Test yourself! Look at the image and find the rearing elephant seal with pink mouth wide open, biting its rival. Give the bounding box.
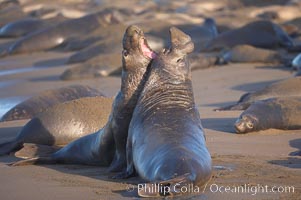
[13,26,155,171]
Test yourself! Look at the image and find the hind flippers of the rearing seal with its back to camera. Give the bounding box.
[138,173,192,197]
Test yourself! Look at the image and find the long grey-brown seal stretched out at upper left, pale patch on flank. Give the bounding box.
[2,10,119,56]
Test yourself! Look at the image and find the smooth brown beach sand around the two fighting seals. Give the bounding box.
[0,52,301,200]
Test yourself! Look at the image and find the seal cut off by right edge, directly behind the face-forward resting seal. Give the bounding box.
[215,77,301,111]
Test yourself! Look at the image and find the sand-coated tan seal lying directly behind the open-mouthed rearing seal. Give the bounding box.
[0,97,113,155]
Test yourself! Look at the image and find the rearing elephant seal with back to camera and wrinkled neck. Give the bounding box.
[116,27,212,195]
